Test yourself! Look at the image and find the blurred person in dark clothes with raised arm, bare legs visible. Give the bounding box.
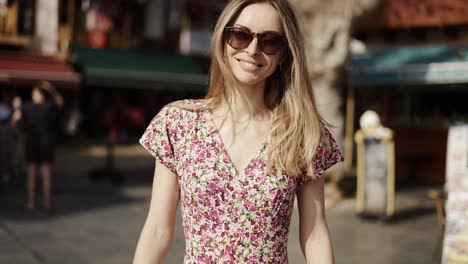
[14,81,64,212]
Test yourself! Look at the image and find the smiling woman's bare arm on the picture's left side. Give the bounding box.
[133,161,179,264]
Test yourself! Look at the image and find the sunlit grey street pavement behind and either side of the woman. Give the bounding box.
[0,145,439,264]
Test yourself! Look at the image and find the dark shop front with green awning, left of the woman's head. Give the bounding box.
[72,46,208,142]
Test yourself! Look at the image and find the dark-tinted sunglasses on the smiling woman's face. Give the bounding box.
[225,27,286,55]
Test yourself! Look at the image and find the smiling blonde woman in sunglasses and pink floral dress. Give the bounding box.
[134,0,342,263]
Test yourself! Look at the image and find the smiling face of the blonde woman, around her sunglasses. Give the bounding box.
[225,3,284,87]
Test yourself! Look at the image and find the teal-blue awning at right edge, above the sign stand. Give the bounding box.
[349,46,468,86]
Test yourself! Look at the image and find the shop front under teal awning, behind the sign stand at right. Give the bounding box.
[347,45,468,186]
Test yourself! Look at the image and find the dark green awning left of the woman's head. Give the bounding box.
[72,46,208,90]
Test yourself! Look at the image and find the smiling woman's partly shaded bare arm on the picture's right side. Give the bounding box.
[297,178,334,264]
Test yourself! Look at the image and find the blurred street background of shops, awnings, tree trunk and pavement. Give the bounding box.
[0,0,468,263]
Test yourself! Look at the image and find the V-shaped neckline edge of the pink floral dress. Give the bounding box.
[207,108,270,176]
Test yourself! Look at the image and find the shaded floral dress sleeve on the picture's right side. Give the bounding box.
[304,122,344,183]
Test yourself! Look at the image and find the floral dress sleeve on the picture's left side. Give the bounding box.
[139,107,176,173]
